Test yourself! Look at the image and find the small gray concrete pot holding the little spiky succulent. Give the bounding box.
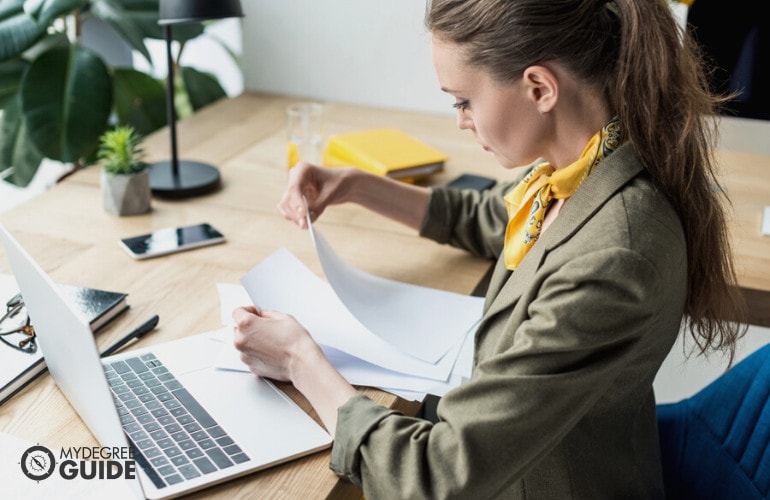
[102,170,151,215]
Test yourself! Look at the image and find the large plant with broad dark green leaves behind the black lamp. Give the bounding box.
[0,0,234,187]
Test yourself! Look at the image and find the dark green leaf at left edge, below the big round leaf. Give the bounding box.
[0,96,43,187]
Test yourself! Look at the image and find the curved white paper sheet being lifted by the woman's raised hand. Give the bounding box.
[308,218,482,363]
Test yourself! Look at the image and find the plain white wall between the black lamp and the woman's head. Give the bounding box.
[241,0,452,113]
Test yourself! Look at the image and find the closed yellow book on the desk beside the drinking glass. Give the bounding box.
[323,128,447,181]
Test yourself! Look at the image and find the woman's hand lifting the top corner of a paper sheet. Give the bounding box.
[278,162,356,229]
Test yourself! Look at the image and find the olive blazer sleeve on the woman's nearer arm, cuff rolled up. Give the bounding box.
[331,247,676,499]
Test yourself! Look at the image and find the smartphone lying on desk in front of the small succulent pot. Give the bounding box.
[120,223,225,260]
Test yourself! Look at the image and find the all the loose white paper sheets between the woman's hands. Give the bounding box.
[218,221,483,400]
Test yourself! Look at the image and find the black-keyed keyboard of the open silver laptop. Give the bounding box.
[104,353,249,488]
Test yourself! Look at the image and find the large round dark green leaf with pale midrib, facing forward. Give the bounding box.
[21,45,112,162]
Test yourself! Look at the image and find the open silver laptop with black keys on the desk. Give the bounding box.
[0,225,332,499]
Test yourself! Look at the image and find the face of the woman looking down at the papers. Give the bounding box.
[433,36,547,168]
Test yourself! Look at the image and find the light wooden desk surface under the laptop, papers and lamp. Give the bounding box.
[0,94,770,498]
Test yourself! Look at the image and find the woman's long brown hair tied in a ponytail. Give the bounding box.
[425,0,747,360]
